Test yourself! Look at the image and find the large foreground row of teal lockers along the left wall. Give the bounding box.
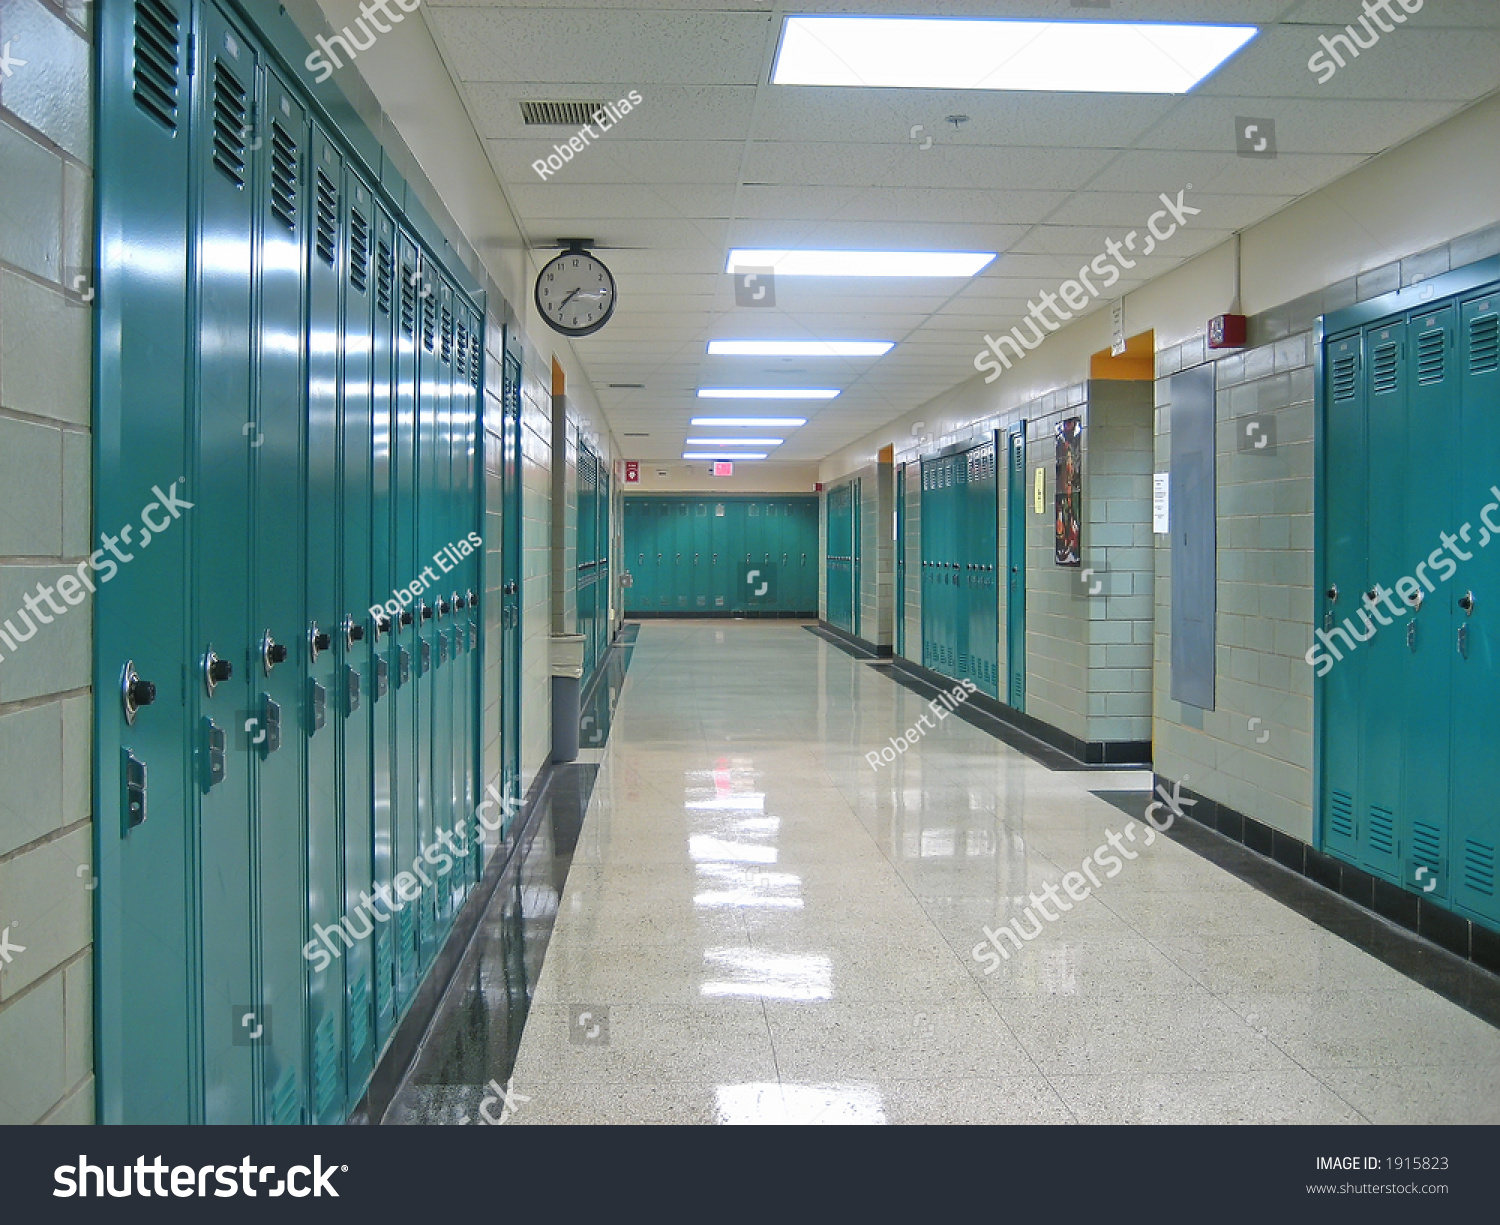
[95,0,501,1123]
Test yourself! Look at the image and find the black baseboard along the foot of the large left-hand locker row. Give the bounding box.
[350,762,555,1123]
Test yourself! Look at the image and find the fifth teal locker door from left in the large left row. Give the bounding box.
[333,166,377,1101]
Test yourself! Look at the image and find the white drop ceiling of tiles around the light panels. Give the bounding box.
[425,0,1500,462]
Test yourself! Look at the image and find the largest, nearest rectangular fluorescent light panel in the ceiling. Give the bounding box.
[774,16,1259,94]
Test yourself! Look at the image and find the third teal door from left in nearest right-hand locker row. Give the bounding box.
[1392,304,1452,901]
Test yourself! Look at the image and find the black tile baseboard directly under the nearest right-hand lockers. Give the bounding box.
[1154,774,1500,983]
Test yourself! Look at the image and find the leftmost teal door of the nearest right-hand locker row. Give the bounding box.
[1314,334,1368,859]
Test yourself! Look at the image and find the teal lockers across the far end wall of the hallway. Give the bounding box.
[624,495,818,616]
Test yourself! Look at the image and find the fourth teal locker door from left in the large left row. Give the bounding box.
[306,124,353,1123]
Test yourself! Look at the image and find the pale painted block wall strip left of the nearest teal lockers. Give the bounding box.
[0,0,95,1123]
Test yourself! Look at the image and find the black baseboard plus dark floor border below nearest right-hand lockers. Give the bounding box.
[1152,774,1500,1027]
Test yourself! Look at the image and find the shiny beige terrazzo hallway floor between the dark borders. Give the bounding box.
[507,622,1500,1125]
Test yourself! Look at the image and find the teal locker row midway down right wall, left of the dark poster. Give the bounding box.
[921,423,1026,711]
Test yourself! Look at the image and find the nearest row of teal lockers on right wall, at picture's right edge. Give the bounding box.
[1326,261,1500,928]
